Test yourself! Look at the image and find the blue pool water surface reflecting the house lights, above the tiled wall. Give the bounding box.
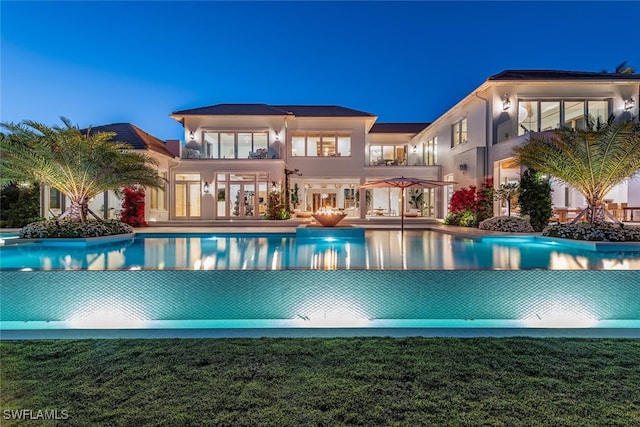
[0,230,640,270]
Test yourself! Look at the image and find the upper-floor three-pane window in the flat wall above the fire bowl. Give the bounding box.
[291,132,351,157]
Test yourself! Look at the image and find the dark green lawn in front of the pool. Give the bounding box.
[0,338,640,427]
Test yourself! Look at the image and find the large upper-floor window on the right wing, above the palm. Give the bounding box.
[518,99,609,135]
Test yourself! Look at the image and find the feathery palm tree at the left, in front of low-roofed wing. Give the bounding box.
[0,117,163,222]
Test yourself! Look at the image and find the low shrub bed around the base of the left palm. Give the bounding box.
[19,219,133,239]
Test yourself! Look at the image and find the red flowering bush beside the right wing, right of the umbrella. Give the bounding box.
[444,178,494,227]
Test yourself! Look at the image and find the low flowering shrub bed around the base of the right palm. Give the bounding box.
[542,222,640,242]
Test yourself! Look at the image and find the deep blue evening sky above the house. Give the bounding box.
[0,0,640,139]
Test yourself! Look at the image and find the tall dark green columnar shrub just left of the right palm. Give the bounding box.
[518,169,553,231]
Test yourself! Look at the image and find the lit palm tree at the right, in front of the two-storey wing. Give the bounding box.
[515,119,640,223]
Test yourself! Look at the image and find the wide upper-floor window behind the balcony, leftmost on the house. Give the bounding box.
[202,131,269,159]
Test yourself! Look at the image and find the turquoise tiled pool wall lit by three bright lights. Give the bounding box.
[0,270,640,332]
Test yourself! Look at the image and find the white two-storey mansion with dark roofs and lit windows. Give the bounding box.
[38,70,640,224]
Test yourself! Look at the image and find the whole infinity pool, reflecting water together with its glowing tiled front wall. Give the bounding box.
[0,231,640,338]
